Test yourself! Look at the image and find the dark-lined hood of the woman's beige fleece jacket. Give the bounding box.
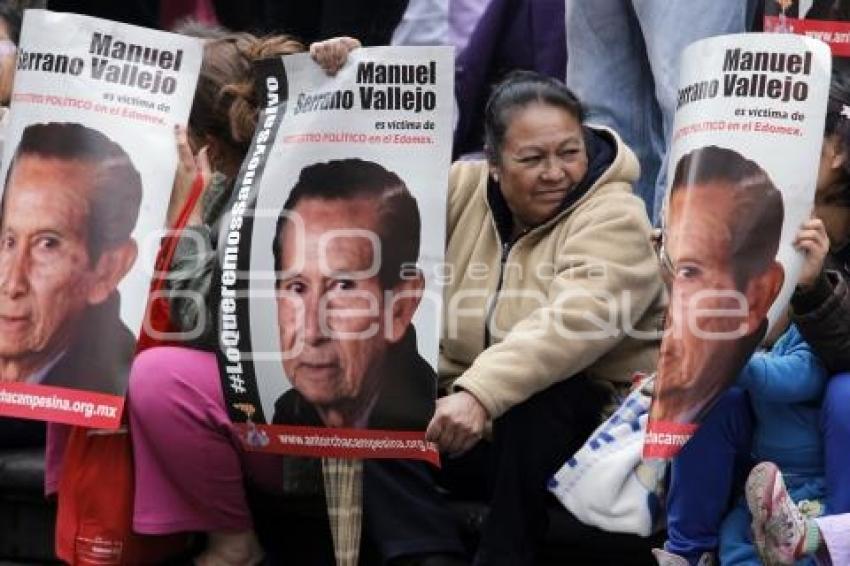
[487,126,640,242]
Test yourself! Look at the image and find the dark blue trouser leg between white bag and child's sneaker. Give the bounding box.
[664,388,752,563]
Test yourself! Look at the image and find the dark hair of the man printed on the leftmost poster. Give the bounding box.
[4,122,142,262]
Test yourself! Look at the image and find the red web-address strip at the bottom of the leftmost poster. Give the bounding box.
[0,382,124,429]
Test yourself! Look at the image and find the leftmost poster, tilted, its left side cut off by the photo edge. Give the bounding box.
[0,10,203,428]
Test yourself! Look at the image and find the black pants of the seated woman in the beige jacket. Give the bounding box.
[442,375,610,566]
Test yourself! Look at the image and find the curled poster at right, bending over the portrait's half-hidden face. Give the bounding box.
[643,34,831,459]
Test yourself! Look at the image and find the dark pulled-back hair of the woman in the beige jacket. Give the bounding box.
[484,71,584,163]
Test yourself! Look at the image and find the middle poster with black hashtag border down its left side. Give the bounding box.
[215,47,453,461]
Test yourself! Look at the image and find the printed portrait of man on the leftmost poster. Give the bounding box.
[0,122,142,395]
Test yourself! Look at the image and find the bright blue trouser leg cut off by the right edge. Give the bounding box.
[821,373,850,514]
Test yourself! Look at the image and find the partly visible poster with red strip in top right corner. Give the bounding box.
[764,0,850,57]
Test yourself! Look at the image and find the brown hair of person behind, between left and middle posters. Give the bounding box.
[184,30,304,173]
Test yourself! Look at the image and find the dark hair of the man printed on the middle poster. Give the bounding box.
[272,159,422,289]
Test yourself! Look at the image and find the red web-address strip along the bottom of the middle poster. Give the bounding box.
[236,424,440,466]
